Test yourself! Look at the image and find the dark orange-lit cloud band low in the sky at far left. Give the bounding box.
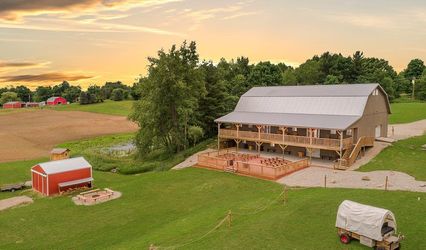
[0,72,94,83]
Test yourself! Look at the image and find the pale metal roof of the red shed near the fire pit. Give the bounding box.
[36,157,92,174]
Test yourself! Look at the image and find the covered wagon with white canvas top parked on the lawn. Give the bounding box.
[336,200,403,250]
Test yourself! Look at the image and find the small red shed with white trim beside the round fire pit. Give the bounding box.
[31,157,93,196]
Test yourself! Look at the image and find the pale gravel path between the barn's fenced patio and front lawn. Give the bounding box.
[277,167,426,192]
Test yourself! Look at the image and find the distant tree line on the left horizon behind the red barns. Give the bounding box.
[0,81,138,104]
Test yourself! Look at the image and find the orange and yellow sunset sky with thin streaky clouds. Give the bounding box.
[0,0,426,89]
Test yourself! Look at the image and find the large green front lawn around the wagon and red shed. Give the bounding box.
[0,164,426,249]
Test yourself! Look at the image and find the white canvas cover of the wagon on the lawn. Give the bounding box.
[336,200,396,241]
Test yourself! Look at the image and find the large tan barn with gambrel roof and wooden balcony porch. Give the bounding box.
[211,84,391,169]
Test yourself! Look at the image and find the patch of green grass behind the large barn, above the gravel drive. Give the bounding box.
[389,102,426,124]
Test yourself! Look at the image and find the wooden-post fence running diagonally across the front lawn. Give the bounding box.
[149,186,287,250]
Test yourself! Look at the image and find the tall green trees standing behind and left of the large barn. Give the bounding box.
[130,42,426,154]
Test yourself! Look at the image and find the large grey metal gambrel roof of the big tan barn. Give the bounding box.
[215,84,386,129]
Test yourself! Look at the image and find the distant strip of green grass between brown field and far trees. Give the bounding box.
[47,100,134,116]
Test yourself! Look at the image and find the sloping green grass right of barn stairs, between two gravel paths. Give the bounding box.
[359,135,426,181]
